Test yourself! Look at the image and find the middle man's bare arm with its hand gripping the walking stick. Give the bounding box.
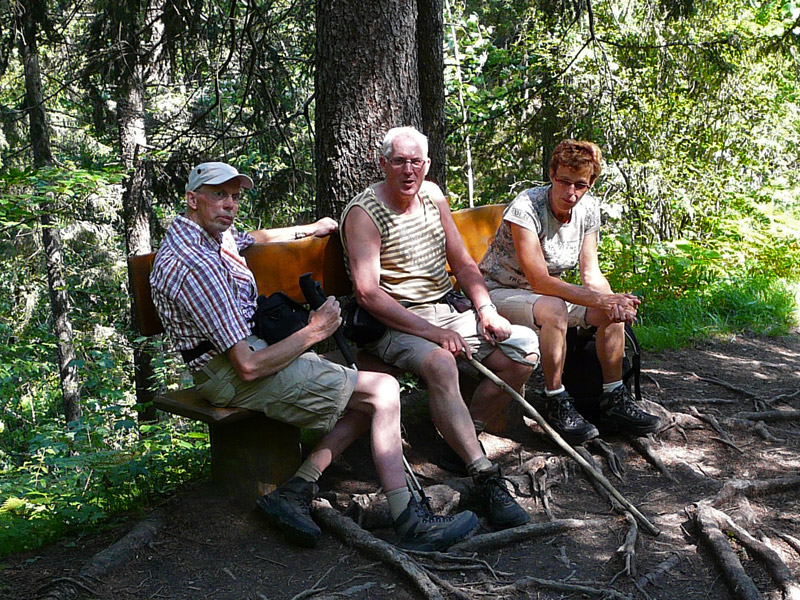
[343,198,476,354]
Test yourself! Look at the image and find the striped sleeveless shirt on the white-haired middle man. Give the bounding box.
[340,184,452,303]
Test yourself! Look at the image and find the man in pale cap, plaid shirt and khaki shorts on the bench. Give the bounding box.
[150,162,477,551]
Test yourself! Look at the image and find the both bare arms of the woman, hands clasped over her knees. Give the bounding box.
[511,223,640,320]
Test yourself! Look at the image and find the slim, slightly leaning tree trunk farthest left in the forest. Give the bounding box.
[18,0,81,422]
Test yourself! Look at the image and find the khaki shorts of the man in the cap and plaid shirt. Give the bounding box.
[194,335,358,432]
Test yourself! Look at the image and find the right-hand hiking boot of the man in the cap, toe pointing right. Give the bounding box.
[394,496,478,552]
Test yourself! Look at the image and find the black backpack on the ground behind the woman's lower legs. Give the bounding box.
[562,323,642,418]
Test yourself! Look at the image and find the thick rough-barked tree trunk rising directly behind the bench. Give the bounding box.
[315,0,422,217]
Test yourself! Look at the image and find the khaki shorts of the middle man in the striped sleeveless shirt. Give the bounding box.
[366,304,497,373]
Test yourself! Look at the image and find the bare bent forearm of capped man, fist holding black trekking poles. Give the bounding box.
[226,296,342,381]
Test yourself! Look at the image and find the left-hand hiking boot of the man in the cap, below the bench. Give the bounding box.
[258,477,322,548]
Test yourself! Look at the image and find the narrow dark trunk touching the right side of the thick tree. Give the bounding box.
[417,0,447,193]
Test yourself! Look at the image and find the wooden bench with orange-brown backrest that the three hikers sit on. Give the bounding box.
[128,205,505,499]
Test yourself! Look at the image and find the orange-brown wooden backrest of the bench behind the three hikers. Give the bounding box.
[128,205,505,336]
